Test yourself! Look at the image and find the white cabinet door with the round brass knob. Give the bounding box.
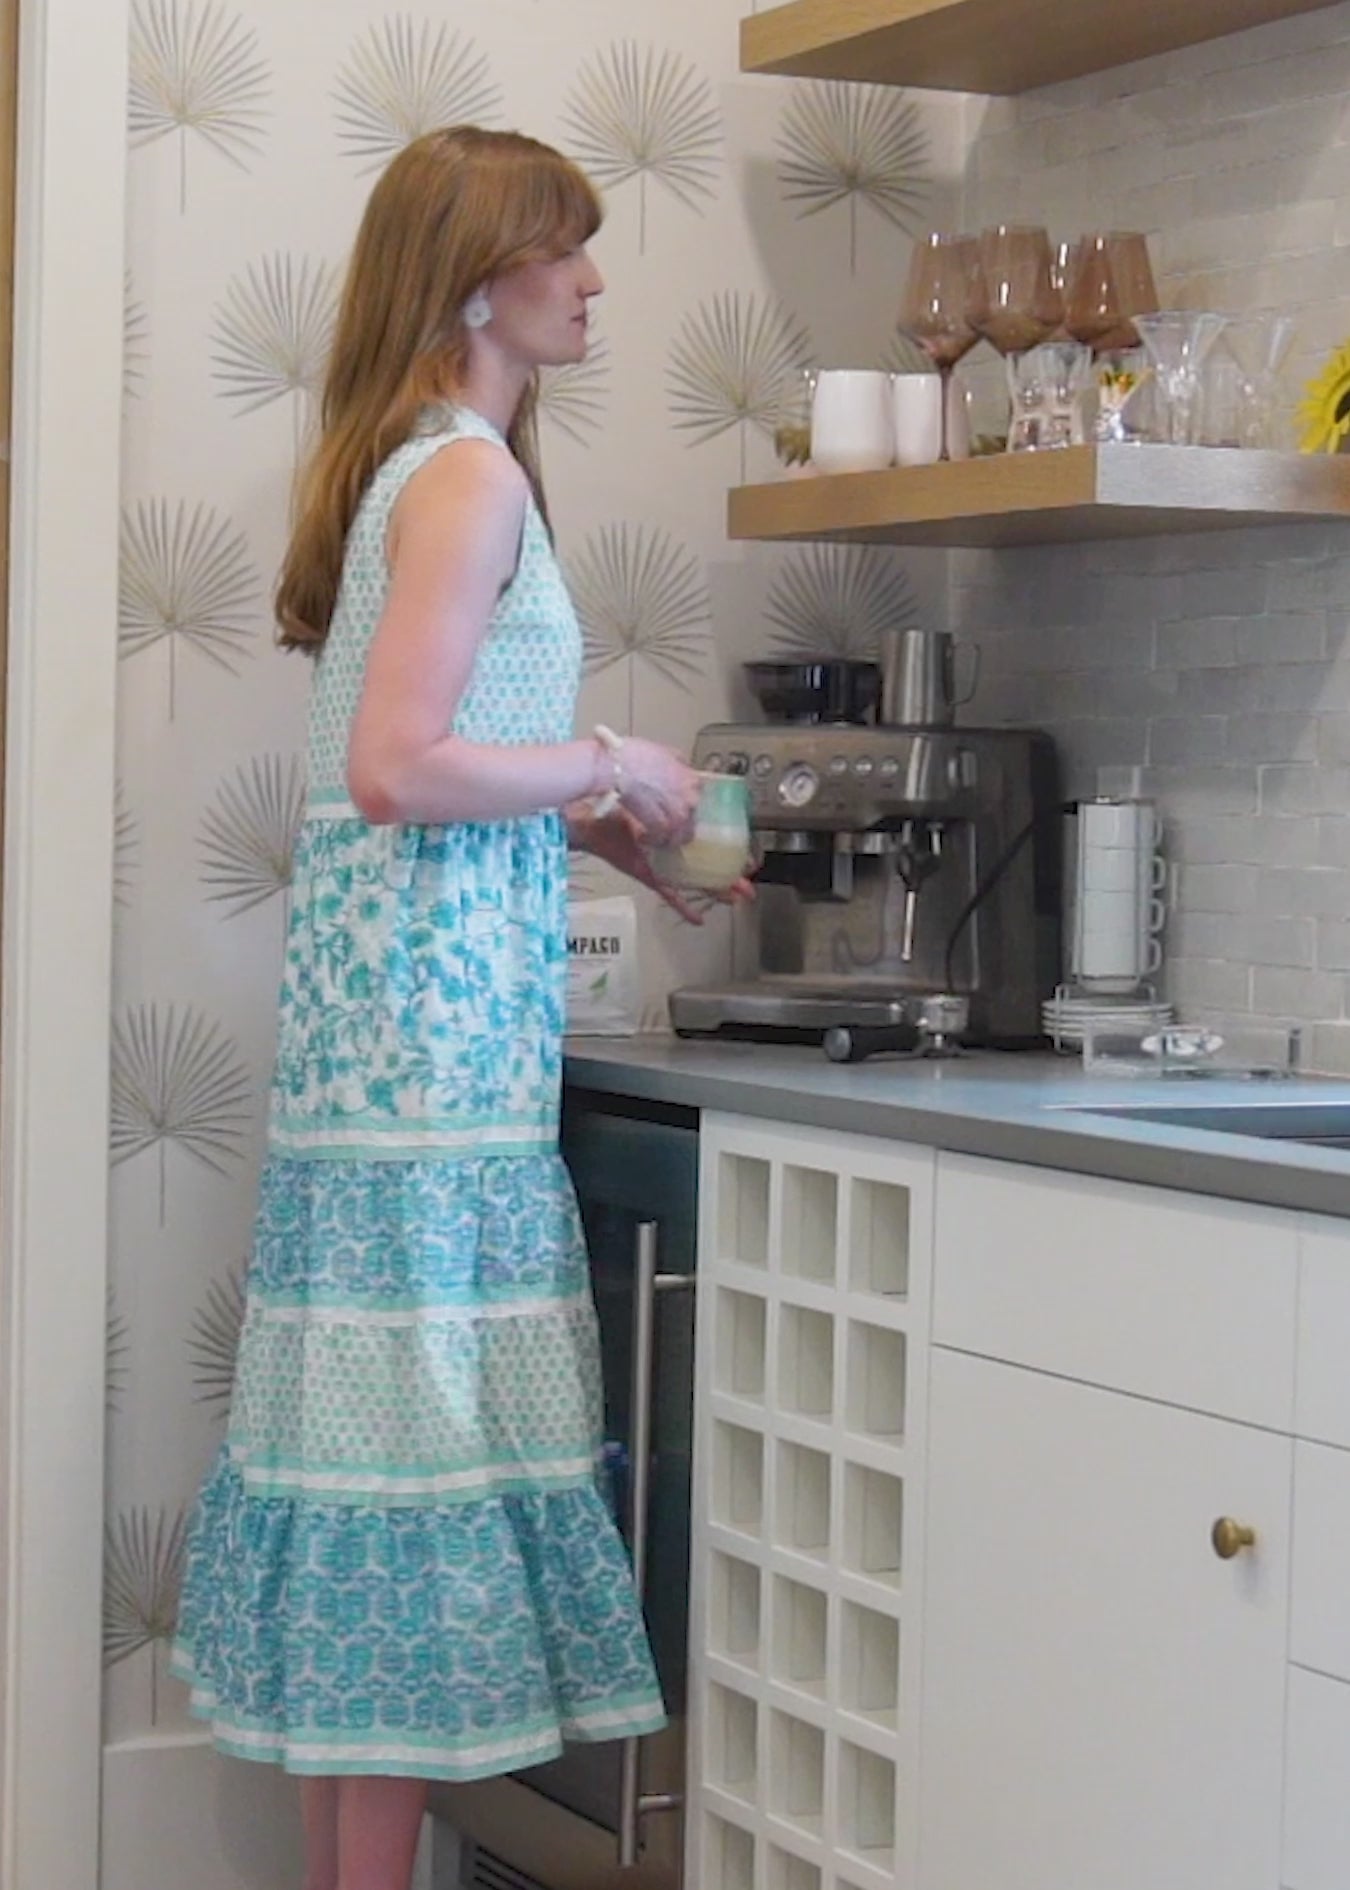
[919,1349,1293,1890]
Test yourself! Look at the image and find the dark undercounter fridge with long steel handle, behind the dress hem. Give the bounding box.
[431,1091,698,1890]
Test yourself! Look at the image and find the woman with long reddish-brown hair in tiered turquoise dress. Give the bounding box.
[174,127,710,1890]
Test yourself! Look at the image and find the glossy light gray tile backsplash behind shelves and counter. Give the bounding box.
[949,4,1350,1074]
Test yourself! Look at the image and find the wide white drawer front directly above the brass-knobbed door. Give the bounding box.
[932,1155,1297,1431]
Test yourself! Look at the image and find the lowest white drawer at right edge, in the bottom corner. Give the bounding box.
[1280,1667,1350,1890]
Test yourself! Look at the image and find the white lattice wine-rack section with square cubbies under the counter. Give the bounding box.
[684,1117,934,1890]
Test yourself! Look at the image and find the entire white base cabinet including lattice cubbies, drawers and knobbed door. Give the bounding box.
[686,1117,1350,1890]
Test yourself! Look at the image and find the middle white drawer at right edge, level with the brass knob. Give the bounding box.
[1289,1444,1350,1685]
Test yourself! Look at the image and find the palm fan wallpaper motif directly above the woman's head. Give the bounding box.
[333,13,501,170]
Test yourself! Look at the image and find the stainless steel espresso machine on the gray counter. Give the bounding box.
[669,631,1063,1060]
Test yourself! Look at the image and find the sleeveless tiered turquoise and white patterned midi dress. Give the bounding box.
[172,408,664,1778]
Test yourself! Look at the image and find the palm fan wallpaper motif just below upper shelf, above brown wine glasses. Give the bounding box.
[777,81,928,270]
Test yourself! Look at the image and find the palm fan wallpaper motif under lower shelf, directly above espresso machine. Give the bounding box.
[764,544,919,662]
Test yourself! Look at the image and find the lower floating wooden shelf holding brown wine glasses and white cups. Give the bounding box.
[728,446,1350,546]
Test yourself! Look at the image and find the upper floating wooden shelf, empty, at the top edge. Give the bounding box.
[741,0,1331,93]
